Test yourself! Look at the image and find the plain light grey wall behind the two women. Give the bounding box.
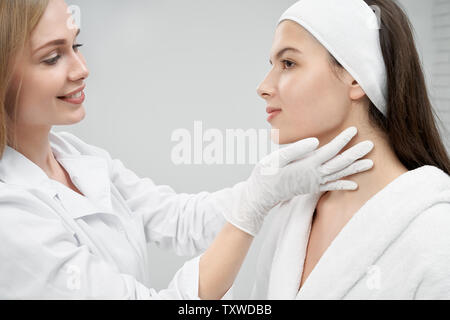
[55,0,450,299]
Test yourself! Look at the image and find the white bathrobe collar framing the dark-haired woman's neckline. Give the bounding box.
[268,166,450,299]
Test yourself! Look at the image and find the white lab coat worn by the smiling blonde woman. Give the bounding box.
[0,132,239,299]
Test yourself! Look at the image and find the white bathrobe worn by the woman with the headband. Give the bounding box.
[252,166,450,299]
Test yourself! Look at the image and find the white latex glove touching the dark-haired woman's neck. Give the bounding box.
[224,127,374,236]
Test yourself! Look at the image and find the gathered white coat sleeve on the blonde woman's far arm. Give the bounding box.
[59,132,241,256]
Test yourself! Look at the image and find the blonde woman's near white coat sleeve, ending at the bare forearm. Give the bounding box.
[0,195,204,300]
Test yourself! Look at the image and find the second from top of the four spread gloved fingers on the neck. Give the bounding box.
[319,140,374,175]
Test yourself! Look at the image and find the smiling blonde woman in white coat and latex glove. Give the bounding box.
[0,0,373,299]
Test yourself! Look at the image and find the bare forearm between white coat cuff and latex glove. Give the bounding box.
[198,223,253,300]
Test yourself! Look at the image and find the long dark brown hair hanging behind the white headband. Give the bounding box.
[330,0,450,174]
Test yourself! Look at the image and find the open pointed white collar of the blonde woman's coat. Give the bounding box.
[0,132,113,216]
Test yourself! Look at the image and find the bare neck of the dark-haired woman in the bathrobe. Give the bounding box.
[317,122,408,220]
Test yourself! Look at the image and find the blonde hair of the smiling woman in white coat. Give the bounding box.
[0,0,49,158]
